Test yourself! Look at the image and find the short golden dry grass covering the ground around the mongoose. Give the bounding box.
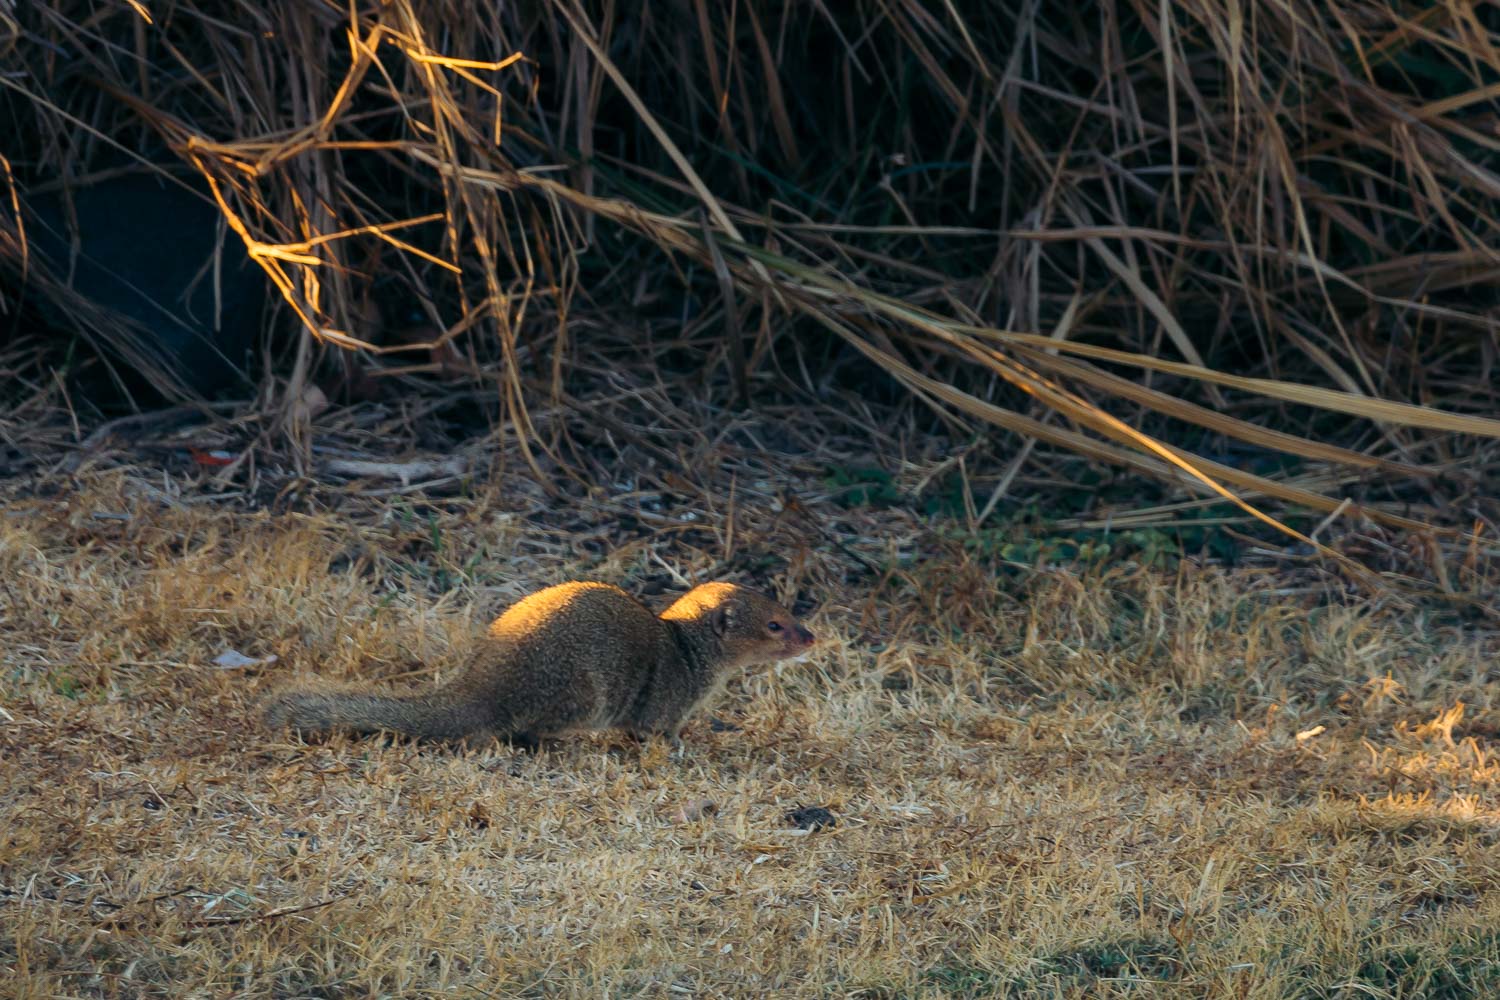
[0,469,1500,999]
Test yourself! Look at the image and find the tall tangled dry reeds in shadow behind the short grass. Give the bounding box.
[0,0,1500,606]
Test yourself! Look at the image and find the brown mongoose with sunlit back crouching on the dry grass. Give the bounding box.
[263,583,813,744]
